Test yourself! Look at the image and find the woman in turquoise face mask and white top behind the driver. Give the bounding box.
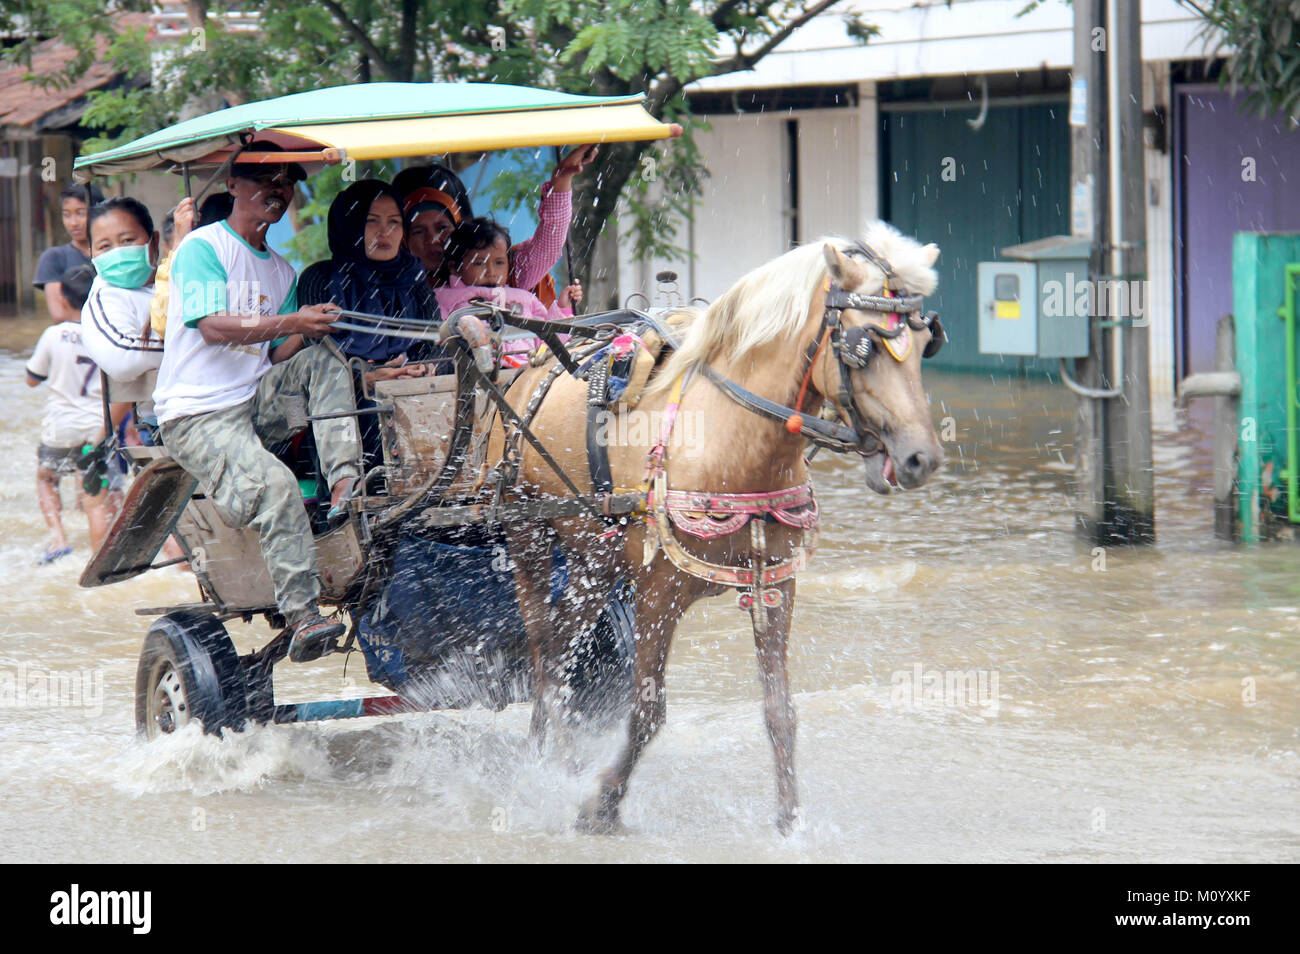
[82,198,163,443]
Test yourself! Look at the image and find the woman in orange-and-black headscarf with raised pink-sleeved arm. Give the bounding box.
[393,146,597,289]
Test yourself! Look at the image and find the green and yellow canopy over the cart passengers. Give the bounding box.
[74,83,681,182]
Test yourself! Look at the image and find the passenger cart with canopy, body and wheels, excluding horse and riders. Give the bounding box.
[75,83,680,737]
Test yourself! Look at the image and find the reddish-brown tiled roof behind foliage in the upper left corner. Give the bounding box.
[0,14,151,136]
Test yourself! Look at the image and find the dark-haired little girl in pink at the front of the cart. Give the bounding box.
[433,218,581,365]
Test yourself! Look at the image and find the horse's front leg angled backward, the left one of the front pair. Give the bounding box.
[577,590,676,834]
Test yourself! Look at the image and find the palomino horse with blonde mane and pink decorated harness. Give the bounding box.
[490,222,944,833]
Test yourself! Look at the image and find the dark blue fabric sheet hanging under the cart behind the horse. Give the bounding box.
[358,535,568,691]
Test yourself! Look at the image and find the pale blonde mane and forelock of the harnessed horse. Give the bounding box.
[647,222,939,391]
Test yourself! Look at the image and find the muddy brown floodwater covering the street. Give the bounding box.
[0,320,1300,862]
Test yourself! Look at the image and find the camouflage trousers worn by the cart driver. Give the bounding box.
[160,344,361,617]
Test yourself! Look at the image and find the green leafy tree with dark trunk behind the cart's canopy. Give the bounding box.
[0,0,874,291]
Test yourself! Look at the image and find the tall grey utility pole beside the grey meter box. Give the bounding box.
[1070,0,1156,543]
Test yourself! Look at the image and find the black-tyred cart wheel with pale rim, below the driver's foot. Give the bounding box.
[135,612,247,738]
